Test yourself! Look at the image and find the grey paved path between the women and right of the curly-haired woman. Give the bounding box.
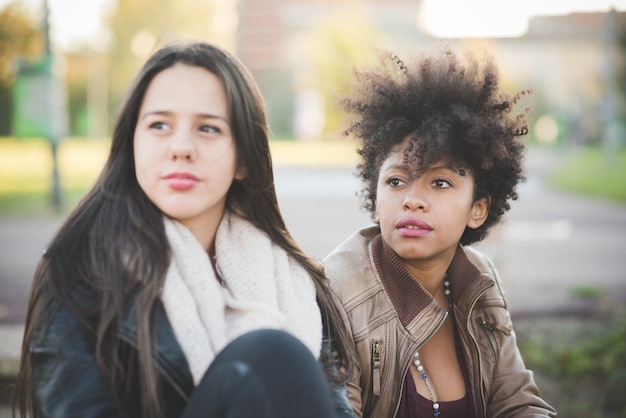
[277,152,626,315]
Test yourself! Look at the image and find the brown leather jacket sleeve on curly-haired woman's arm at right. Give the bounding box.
[486,261,556,417]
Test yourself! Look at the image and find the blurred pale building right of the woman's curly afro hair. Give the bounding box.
[457,12,626,143]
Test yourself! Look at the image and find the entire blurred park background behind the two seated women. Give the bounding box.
[0,0,626,418]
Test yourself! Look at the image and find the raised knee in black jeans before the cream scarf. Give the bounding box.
[181,330,335,418]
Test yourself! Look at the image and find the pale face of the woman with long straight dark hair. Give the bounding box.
[134,64,244,249]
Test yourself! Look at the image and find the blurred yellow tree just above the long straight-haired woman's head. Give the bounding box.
[108,0,229,116]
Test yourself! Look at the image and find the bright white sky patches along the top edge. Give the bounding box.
[0,0,626,49]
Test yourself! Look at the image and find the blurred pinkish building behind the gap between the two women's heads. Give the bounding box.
[237,0,423,137]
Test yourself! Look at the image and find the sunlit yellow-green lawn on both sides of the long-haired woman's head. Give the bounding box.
[0,138,357,215]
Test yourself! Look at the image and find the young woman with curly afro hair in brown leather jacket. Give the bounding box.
[324,46,556,418]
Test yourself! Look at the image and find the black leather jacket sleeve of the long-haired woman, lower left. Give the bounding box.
[29,300,130,418]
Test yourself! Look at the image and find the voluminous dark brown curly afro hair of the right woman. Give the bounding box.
[341,46,531,245]
